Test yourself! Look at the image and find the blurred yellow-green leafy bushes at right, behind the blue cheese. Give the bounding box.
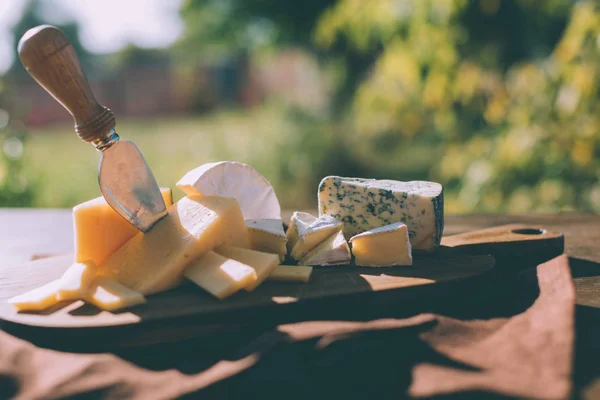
[183,0,600,212]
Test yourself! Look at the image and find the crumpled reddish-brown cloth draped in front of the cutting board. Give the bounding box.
[0,256,575,399]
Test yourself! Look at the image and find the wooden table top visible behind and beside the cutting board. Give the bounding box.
[0,209,600,398]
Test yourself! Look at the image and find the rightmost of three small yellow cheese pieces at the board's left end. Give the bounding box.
[85,276,146,311]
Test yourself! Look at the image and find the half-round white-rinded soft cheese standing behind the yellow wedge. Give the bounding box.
[177,161,281,220]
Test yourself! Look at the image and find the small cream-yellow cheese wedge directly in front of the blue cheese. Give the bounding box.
[350,222,412,267]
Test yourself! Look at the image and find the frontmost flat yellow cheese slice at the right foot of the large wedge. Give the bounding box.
[184,251,257,299]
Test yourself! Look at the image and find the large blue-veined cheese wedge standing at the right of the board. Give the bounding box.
[318,176,444,251]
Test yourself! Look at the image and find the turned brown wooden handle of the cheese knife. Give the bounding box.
[18,25,115,143]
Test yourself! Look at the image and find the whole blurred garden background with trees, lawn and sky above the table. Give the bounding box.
[0,0,600,213]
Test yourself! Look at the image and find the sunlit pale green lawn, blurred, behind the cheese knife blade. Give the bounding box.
[23,108,292,207]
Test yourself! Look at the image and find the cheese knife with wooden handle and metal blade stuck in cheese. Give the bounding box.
[18,25,167,232]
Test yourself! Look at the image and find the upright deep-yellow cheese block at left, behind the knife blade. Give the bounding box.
[73,188,173,265]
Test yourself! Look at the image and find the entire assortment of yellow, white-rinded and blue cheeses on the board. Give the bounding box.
[9,161,444,311]
